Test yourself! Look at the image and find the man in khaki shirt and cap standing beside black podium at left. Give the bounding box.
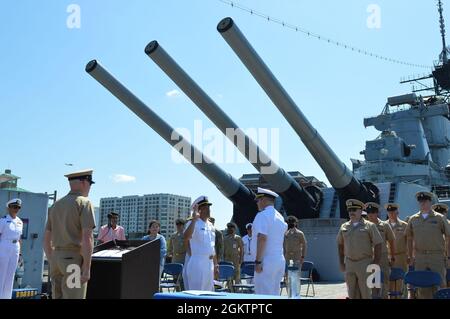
[44,170,95,299]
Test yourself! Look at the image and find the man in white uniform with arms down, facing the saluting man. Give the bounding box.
[252,187,287,295]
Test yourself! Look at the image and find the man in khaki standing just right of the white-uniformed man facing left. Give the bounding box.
[283,216,306,267]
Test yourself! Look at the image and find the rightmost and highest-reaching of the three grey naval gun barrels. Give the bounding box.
[217,18,377,216]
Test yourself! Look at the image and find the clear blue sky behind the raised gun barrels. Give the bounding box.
[0,0,450,227]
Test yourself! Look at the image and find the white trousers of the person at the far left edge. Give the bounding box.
[0,240,20,299]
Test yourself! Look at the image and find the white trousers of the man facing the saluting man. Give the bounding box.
[254,255,286,296]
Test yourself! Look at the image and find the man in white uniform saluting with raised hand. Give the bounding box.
[184,196,218,291]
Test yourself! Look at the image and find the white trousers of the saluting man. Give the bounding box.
[186,255,214,291]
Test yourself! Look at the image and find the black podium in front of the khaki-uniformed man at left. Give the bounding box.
[86,240,161,299]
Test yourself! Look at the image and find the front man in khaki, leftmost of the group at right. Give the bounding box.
[337,199,383,299]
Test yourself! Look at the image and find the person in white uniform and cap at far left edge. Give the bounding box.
[0,198,23,299]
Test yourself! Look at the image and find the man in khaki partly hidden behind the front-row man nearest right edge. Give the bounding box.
[384,203,409,298]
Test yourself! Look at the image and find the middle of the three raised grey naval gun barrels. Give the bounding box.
[145,41,321,218]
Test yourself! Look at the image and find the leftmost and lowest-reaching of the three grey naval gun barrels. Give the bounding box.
[86,60,257,230]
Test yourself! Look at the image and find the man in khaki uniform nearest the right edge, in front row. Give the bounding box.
[406,192,450,299]
